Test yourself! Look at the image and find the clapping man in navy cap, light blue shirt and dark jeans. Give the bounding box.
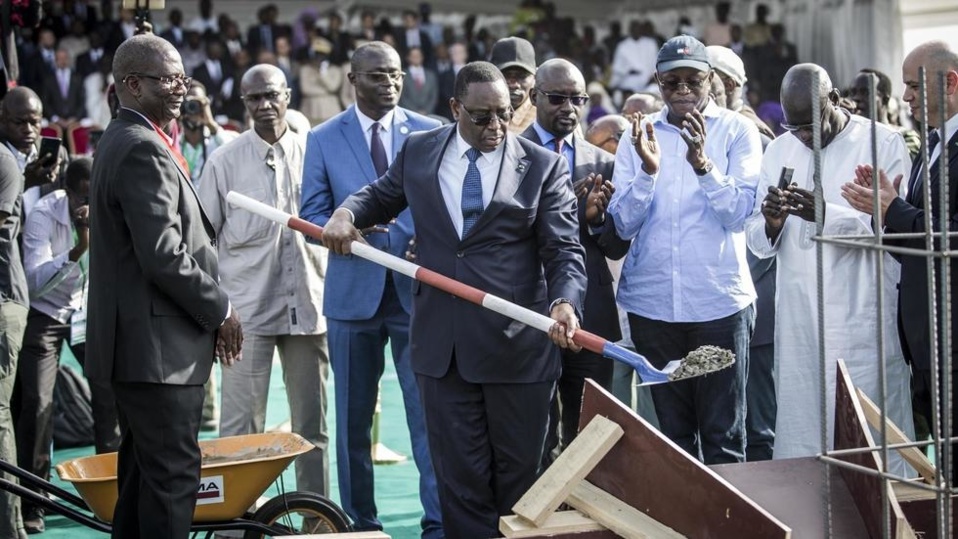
[609,36,762,464]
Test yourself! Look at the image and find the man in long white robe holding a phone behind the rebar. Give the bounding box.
[746,64,913,468]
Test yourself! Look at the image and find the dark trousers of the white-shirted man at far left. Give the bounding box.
[17,309,120,504]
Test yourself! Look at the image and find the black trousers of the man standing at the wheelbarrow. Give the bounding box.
[113,382,203,539]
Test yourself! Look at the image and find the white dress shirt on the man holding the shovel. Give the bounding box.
[439,127,508,238]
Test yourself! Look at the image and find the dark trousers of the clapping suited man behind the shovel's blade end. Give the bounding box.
[542,350,613,467]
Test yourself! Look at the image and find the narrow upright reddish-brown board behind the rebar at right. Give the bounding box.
[835,360,915,539]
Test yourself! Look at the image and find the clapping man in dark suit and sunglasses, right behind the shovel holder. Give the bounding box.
[522,59,630,462]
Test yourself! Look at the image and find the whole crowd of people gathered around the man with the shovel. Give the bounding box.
[0,0,958,538]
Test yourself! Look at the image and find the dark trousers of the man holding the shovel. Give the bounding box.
[417,358,555,539]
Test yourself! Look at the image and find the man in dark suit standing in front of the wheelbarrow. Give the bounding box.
[86,34,242,538]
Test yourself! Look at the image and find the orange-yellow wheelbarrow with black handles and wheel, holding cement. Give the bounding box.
[0,432,352,539]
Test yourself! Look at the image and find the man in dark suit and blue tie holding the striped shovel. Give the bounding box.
[324,62,586,537]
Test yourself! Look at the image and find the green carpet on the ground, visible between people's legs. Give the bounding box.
[32,349,422,539]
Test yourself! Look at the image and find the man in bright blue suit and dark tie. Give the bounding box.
[299,41,442,538]
